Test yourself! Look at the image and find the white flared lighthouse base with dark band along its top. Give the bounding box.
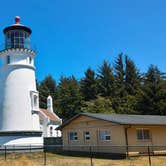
[0,131,43,146]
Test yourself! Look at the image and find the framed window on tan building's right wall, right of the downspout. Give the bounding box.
[136,128,152,141]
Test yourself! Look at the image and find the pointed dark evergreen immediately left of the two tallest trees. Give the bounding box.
[98,61,115,97]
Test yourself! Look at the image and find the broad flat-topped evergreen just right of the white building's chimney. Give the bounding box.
[57,76,82,120]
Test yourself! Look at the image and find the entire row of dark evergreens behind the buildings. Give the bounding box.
[37,53,166,120]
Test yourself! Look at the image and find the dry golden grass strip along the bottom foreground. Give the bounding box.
[0,153,166,166]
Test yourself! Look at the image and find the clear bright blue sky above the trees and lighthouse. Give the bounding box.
[0,0,166,81]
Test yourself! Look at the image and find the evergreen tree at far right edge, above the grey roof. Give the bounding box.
[138,65,166,115]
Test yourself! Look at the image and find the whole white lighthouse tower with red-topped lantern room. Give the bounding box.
[0,16,43,145]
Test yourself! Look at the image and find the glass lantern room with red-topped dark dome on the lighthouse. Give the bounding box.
[3,16,32,49]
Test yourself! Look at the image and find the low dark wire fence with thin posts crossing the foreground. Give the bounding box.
[0,145,166,166]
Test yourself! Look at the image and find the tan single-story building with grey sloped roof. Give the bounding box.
[60,113,166,153]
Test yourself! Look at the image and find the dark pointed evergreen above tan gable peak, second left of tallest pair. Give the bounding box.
[80,68,97,101]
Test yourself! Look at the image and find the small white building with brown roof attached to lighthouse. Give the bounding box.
[39,96,62,137]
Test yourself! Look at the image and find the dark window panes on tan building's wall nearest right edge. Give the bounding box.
[137,129,150,141]
